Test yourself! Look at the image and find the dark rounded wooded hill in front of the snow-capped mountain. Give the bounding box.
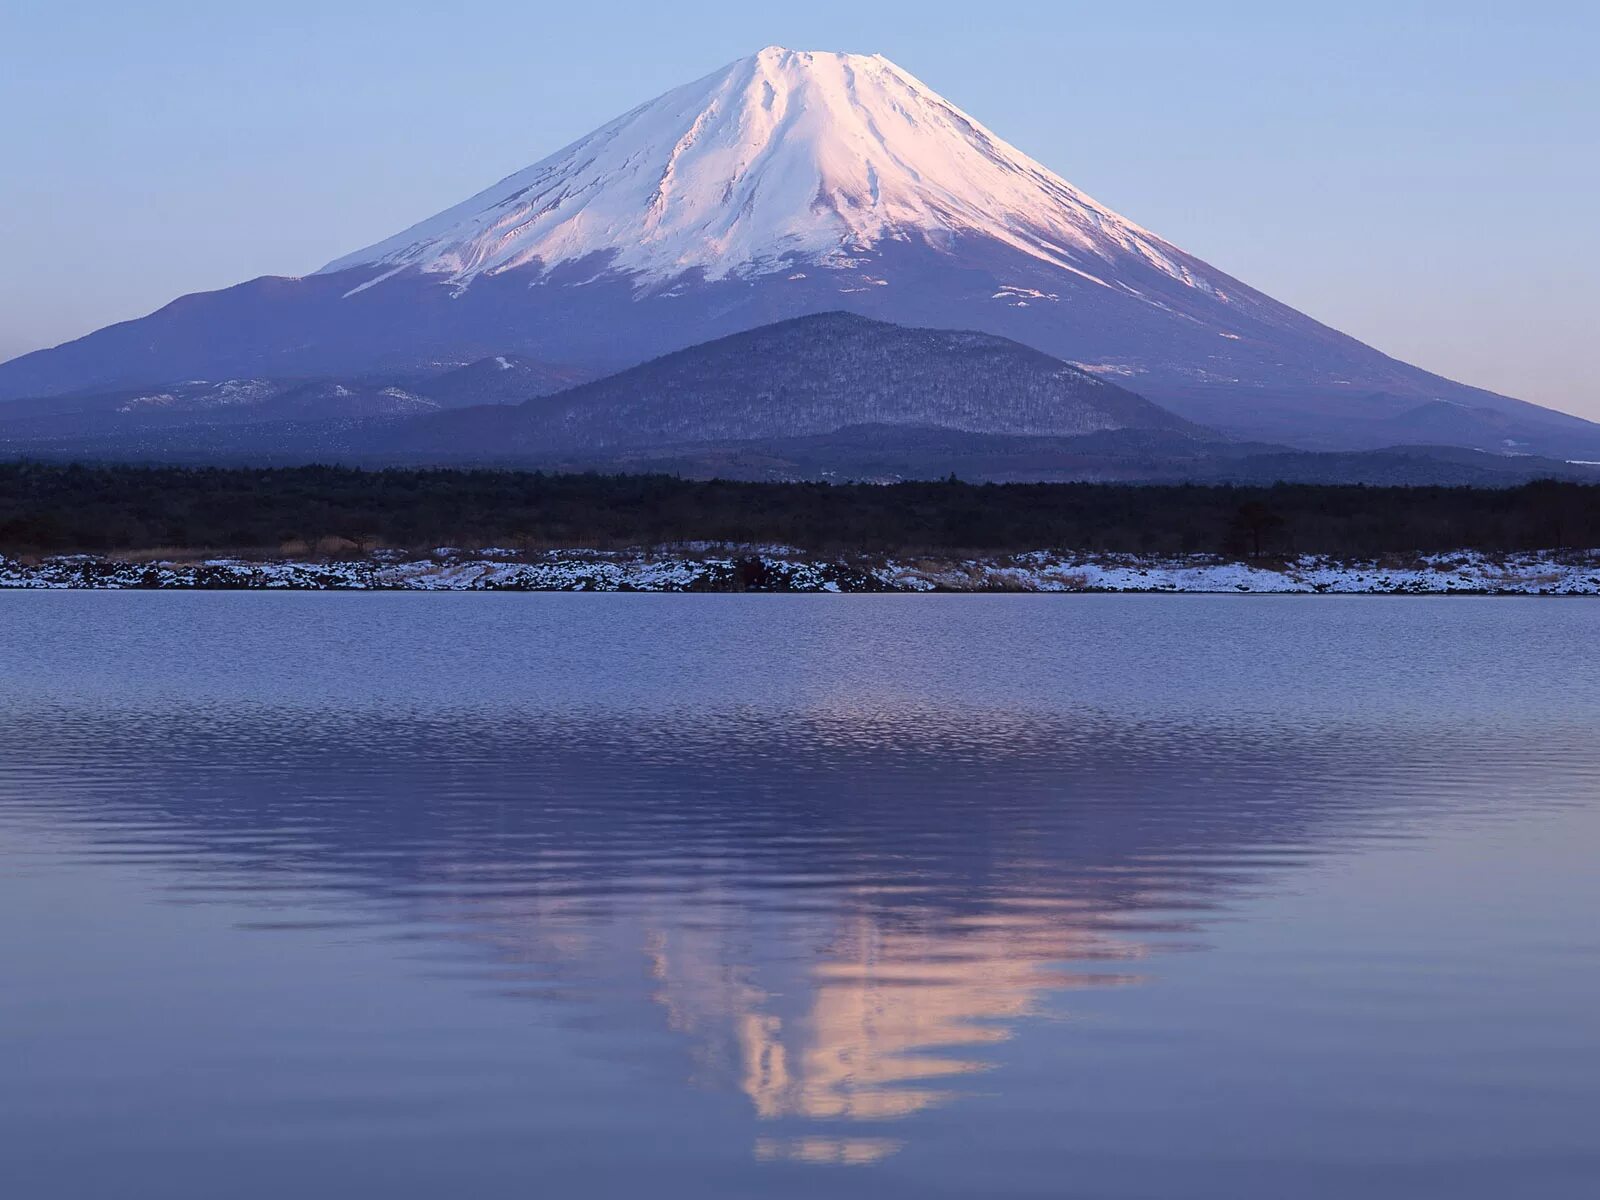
[373,312,1202,459]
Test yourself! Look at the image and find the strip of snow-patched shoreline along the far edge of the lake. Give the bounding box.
[0,547,1600,595]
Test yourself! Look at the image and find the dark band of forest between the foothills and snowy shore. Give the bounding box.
[0,462,1600,557]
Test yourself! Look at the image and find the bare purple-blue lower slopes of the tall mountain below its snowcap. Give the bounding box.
[15,245,1600,459]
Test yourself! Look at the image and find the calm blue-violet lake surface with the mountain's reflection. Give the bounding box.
[0,594,1600,1200]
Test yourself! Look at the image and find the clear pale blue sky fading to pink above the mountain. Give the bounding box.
[0,0,1600,419]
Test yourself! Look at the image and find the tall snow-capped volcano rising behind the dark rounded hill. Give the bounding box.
[0,46,1600,458]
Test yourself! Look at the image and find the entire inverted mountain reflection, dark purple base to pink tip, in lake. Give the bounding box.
[0,704,1561,1162]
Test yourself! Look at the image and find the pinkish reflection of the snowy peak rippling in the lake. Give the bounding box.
[651,909,1141,1149]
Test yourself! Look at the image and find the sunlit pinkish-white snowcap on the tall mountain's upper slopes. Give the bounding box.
[322,46,1214,299]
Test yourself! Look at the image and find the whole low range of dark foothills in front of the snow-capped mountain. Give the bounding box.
[0,312,1600,486]
